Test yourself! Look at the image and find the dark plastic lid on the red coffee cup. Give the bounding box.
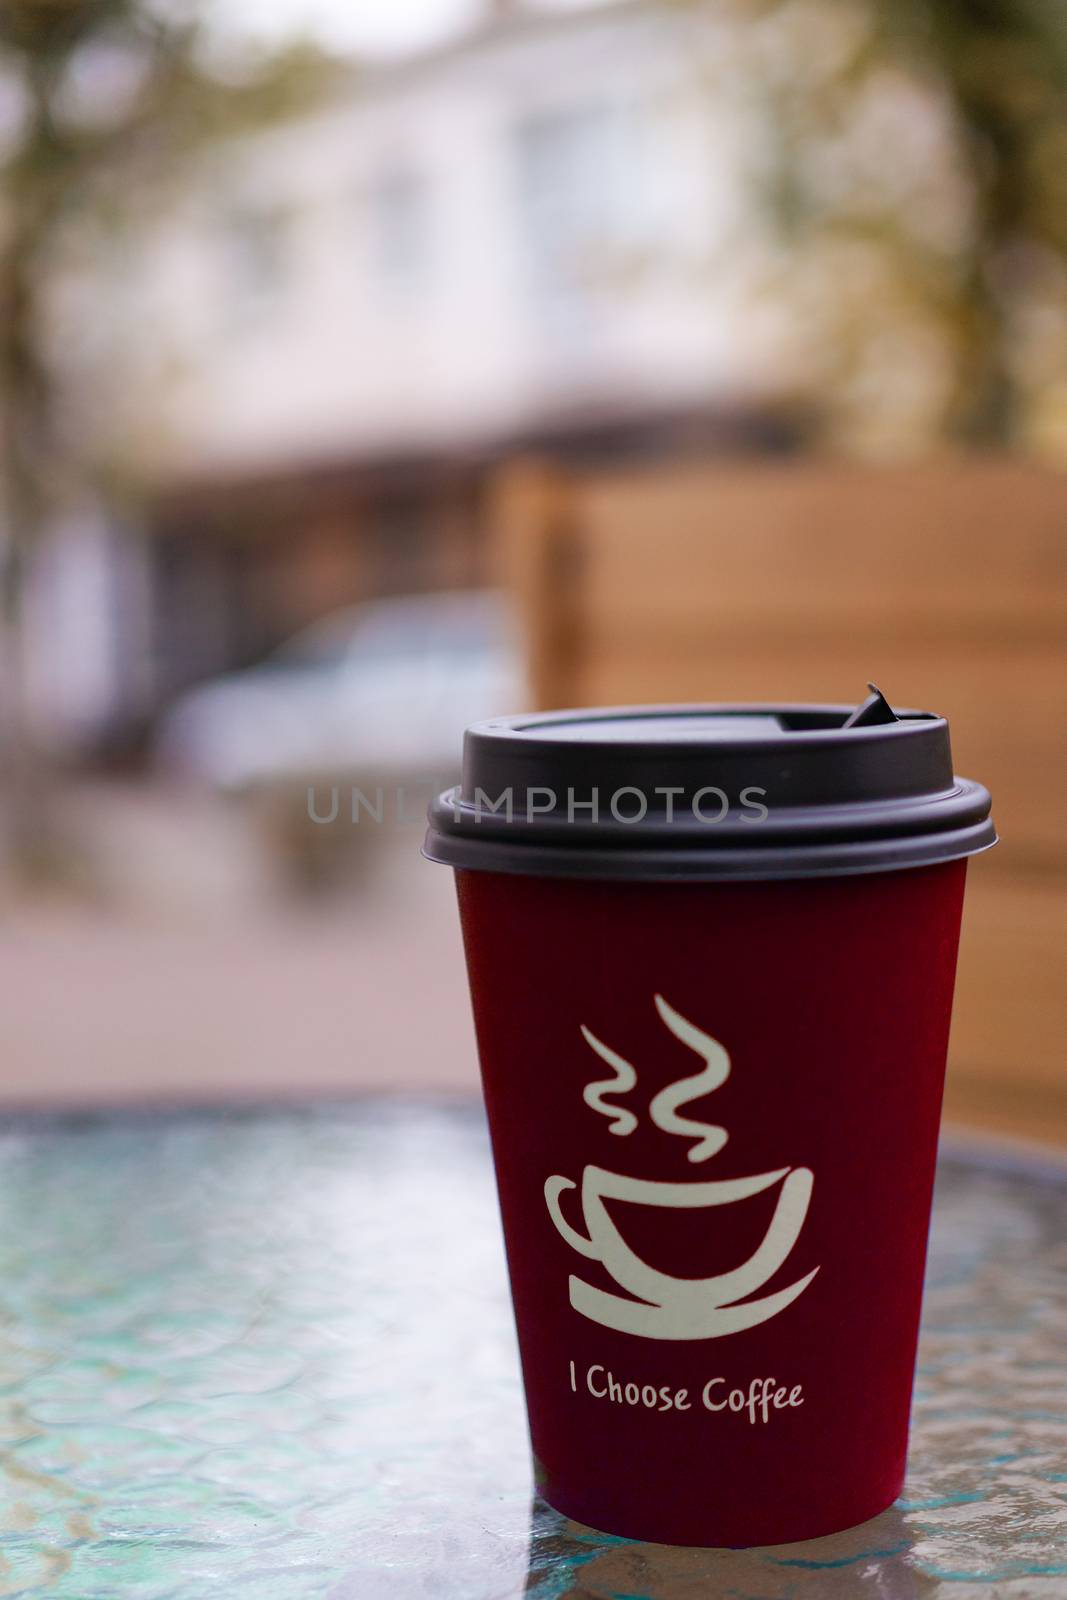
[424,685,997,882]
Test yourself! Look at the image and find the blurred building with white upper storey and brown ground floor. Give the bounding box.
[49,0,812,748]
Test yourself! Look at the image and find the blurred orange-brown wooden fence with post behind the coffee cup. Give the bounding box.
[494,459,1067,1141]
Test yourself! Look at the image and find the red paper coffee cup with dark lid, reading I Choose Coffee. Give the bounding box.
[426,698,995,1546]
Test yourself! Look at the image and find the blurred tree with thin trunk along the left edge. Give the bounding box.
[0,0,339,874]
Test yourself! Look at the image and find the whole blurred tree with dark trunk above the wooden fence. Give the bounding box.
[741,0,1067,451]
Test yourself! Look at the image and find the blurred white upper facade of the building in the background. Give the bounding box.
[112,0,781,472]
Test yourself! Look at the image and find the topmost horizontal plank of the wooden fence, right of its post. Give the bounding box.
[574,461,1067,638]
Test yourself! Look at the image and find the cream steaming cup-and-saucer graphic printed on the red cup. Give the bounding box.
[544,995,819,1339]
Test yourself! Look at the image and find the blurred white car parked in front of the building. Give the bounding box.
[157,590,525,792]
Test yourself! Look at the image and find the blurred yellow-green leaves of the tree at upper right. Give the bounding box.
[749,0,1067,443]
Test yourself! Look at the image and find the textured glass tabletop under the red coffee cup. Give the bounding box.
[0,1102,1067,1600]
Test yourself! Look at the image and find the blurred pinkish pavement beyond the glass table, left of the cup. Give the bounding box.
[0,780,477,1106]
